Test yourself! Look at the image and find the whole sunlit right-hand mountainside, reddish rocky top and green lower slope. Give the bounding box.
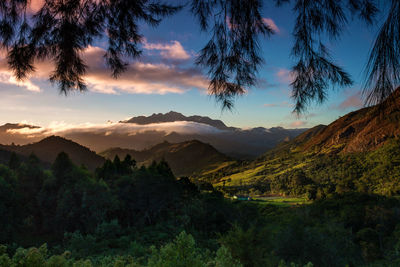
[192,89,400,194]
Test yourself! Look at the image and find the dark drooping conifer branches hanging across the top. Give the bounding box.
[0,0,400,112]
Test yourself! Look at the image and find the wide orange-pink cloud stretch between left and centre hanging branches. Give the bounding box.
[84,47,208,94]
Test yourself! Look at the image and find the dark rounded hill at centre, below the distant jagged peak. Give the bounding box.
[100,140,229,176]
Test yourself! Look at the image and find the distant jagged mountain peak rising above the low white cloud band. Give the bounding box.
[121,111,236,130]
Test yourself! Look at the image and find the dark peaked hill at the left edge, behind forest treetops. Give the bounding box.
[0,136,104,170]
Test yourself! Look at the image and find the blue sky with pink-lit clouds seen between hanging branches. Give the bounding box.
[0,0,386,128]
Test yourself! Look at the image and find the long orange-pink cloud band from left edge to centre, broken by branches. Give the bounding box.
[0,46,208,94]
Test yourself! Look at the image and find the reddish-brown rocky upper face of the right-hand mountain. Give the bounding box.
[298,88,400,153]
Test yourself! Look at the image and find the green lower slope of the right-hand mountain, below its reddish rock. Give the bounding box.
[192,139,400,198]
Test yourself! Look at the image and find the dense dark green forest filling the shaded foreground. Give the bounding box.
[0,151,400,267]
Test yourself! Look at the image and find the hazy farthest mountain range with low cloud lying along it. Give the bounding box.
[0,111,307,159]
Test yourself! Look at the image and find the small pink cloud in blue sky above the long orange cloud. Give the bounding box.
[143,40,190,60]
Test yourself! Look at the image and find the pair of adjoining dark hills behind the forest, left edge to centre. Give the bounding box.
[0,136,230,176]
